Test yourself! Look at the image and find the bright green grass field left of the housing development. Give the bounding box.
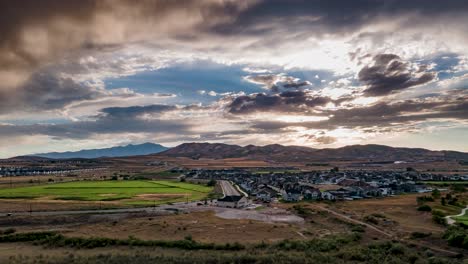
[0,180,213,205]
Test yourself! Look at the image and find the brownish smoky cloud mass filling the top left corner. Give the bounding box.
[0,0,252,88]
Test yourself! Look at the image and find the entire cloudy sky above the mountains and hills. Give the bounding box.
[0,0,468,158]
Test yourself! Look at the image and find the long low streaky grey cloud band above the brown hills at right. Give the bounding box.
[249,93,468,131]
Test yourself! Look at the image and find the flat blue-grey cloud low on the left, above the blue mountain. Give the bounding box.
[0,105,190,139]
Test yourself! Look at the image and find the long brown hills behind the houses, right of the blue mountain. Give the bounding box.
[158,143,468,162]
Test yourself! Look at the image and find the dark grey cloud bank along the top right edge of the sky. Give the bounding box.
[214,0,468,35]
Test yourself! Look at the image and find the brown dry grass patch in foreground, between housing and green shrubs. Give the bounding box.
[67,212,302,243]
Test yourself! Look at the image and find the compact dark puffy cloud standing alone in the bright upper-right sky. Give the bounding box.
[358,54,436,96]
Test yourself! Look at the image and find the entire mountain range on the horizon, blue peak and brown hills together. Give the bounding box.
[23,143,468,162]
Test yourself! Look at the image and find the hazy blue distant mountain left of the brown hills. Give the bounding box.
[33,143,168,159]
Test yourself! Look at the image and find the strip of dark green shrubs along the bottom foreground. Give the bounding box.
[0,232,462,264]
